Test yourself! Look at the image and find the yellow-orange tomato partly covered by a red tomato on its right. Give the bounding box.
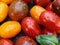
[30,5,45,23]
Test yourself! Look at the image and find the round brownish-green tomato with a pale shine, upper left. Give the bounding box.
[9,0,28,21]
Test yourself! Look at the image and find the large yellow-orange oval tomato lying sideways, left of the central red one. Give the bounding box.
[0,21,21,38]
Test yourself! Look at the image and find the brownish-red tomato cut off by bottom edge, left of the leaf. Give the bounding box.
[16,36,37,45]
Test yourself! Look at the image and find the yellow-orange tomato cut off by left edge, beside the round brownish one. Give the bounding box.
[0,2,8,22]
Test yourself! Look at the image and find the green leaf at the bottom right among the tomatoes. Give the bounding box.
[36,35,58,45]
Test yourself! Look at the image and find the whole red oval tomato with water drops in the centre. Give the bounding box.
[21,17,41,39]
